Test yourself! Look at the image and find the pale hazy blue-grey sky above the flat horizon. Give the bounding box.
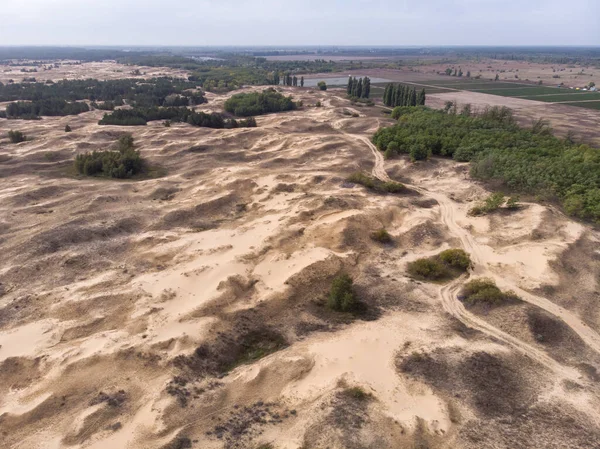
[0,0,600,46]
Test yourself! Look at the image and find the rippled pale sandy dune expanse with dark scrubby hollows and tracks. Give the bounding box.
[0,89,600,449]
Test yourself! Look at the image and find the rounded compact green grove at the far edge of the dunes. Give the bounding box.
[225,88,298,117]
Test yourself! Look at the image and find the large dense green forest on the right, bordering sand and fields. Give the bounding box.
[373,106,600,222]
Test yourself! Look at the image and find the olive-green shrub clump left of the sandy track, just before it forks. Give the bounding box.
[407,249,472,281]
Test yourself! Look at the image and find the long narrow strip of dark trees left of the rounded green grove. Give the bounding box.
[98,107,256,129]
